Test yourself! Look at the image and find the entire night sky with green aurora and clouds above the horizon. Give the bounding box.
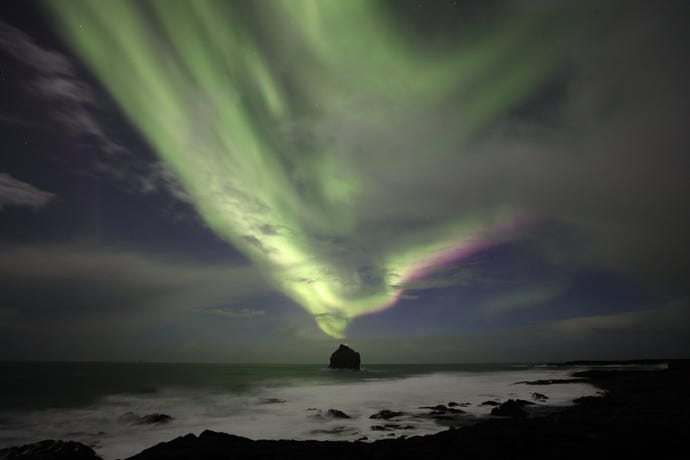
[0,0,690,363]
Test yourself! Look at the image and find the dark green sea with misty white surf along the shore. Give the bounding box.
[0,362,597,460]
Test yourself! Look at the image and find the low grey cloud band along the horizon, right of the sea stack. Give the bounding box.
[350,301,690,363]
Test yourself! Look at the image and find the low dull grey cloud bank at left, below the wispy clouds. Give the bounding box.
[0,245,267,329]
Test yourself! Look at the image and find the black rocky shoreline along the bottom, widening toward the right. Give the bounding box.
[0,365,690,460]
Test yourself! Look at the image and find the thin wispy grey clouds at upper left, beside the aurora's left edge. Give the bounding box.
[0,21,189,208]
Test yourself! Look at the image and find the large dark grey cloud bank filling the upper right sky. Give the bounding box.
[330,2,690,295]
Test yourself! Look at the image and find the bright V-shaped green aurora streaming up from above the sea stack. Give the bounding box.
[45,0,574,338]
